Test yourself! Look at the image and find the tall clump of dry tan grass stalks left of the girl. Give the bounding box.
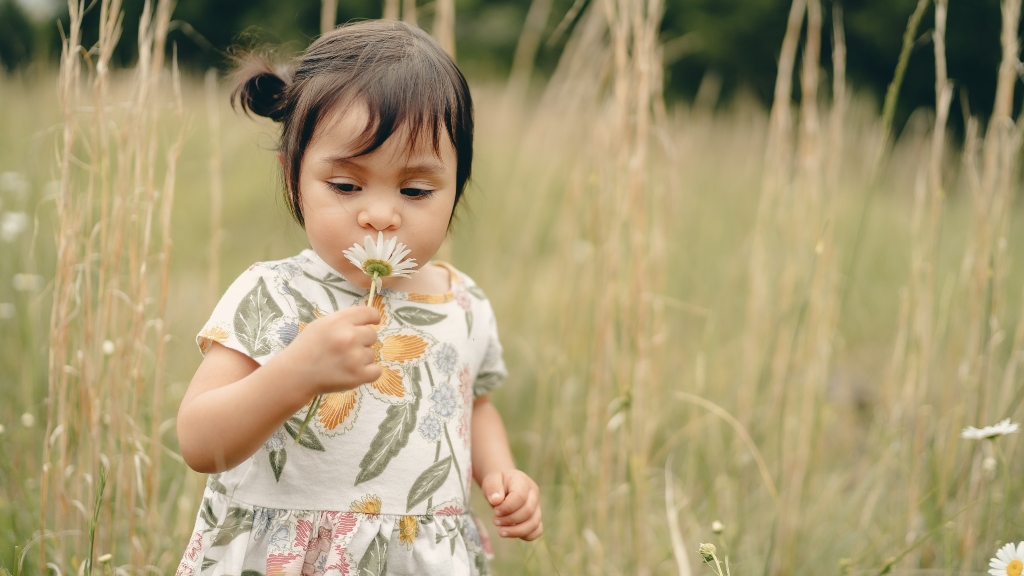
[41,0,185,569]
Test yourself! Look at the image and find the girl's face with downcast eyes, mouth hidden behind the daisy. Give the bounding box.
[299,101,458,292]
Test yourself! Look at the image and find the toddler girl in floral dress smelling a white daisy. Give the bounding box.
[177,22,543,576]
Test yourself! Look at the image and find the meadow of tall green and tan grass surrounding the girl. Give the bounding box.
[0,0,1024,576]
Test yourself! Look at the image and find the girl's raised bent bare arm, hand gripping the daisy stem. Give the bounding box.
[177,306,381,474]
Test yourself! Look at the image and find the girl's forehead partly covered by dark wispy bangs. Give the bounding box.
[307,100,456,163]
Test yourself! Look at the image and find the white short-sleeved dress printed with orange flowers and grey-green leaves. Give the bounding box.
[177,249,506,576]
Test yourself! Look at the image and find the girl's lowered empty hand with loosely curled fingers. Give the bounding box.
[480,469,544,540]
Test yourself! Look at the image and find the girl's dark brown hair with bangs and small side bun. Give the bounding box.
[231,20,473,225]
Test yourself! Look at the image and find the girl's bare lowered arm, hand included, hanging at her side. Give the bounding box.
[472,396,544,540]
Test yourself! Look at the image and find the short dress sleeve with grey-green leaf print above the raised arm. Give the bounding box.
[196,263,299,365]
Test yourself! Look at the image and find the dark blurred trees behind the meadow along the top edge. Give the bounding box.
[0,0,1020,131]
